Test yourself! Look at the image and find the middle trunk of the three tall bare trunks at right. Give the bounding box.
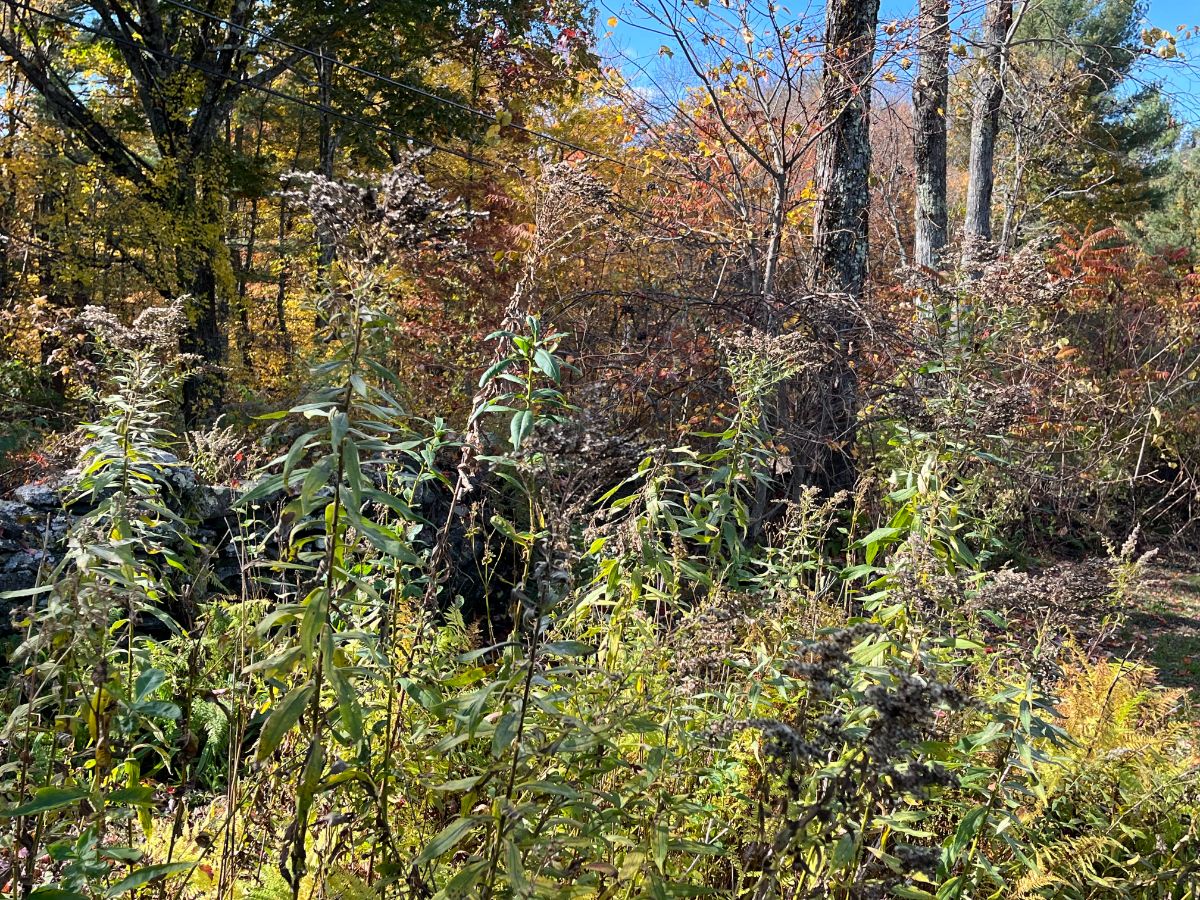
[912,0,950,269]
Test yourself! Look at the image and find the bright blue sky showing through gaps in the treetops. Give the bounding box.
[598,0,1200,125]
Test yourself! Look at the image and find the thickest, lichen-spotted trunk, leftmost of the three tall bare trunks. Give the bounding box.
[793,0,880,493]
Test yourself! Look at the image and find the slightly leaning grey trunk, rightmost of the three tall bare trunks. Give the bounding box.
[962,0,1013,250]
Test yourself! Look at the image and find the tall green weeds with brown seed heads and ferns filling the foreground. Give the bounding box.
[0,169,1200,900]
